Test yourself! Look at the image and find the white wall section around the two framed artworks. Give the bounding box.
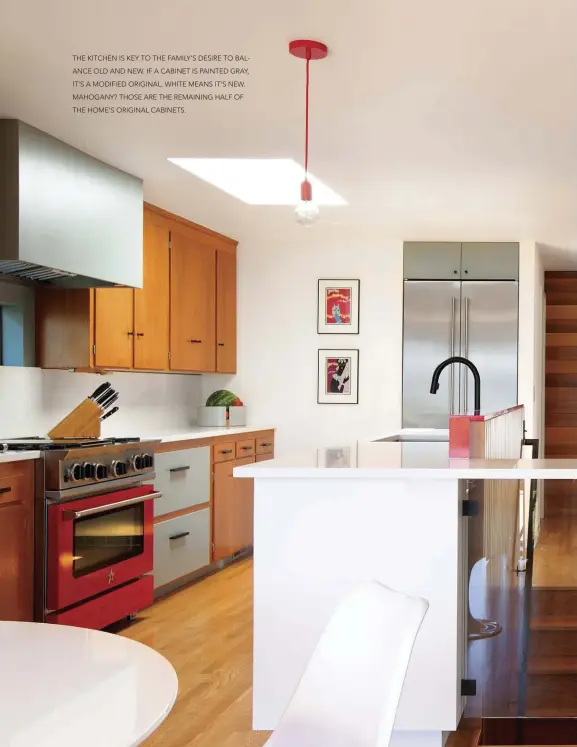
[203,225,403,450]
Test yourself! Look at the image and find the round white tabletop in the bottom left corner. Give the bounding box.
[0,622,178,747]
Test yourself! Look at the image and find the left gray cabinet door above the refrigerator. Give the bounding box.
[403,241,461,280]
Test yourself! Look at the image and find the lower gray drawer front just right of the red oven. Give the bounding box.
[154,508,210,589]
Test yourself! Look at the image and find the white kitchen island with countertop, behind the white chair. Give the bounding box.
[234,431,577,747]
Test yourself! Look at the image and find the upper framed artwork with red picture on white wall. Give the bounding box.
[317,280,361,335]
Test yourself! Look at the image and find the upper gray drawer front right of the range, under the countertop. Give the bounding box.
[154,446,210,516]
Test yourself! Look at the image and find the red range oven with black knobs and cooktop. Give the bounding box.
[2,438,160,629]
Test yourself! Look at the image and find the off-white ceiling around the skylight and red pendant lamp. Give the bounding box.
[0,0,577,250]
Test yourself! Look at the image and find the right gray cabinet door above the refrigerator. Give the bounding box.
[461,241,519,280]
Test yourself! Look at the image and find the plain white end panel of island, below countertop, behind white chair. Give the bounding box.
[253,478,466,732]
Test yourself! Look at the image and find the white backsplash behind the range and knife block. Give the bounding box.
[0,366,202,438]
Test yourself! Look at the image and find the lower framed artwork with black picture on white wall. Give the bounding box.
[317,350,359,405]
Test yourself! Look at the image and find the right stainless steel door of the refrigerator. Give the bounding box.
[460,281,519,414]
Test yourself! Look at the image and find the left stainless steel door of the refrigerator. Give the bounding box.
[403,280,461,428]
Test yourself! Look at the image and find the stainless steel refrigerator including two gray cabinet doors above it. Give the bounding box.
[403,242,519,428]
